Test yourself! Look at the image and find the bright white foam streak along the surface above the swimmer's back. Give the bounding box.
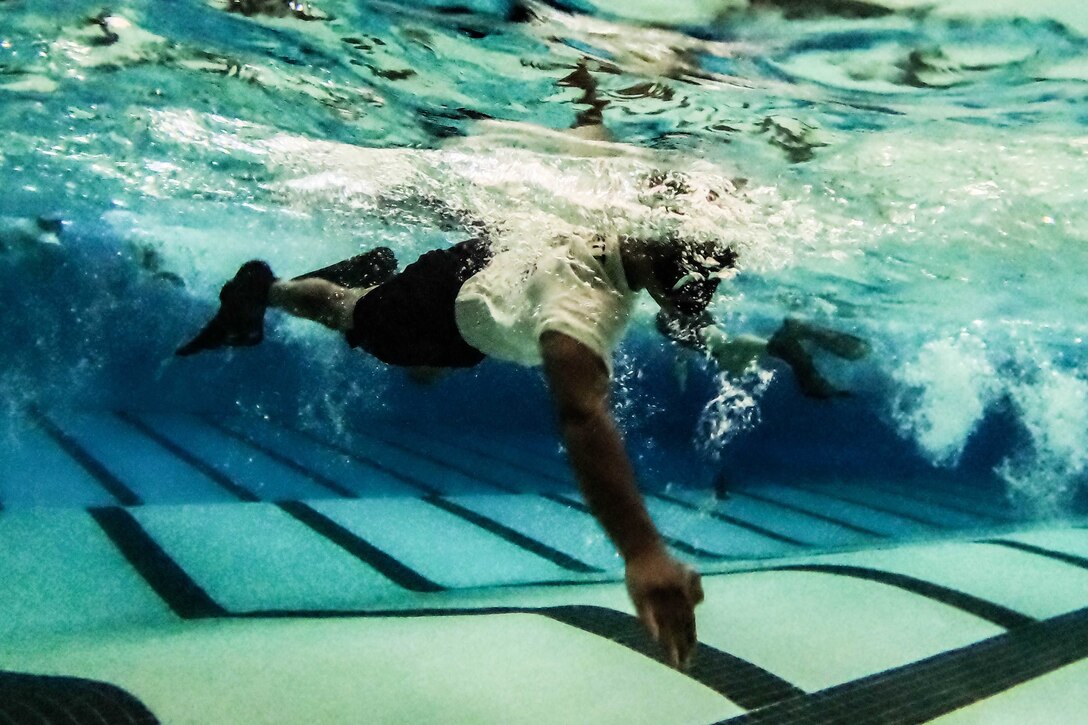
[133,110,809,278]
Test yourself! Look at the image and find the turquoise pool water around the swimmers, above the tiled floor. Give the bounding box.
[0,0,1088,516]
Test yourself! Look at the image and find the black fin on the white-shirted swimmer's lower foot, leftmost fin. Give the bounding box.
[174,260,275,357]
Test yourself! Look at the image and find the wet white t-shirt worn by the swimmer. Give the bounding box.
[456,234,635,372]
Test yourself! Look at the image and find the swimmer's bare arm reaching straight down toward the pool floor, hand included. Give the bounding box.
[541,332,703,667]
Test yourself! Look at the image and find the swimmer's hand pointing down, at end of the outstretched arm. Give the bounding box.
[627,552,703,669]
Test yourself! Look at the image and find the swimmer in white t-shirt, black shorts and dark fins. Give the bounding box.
[171,233,866,667]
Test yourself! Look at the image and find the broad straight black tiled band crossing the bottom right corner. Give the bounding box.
[722,609,1088,725]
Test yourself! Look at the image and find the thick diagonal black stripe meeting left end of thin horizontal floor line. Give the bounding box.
[88,506,228,619]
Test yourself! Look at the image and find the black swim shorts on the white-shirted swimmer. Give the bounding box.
[345,239,491,368]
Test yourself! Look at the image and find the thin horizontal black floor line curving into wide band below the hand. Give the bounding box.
[228,604,804,708]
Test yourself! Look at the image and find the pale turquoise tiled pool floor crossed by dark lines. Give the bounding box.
[0,411,1088,723]
